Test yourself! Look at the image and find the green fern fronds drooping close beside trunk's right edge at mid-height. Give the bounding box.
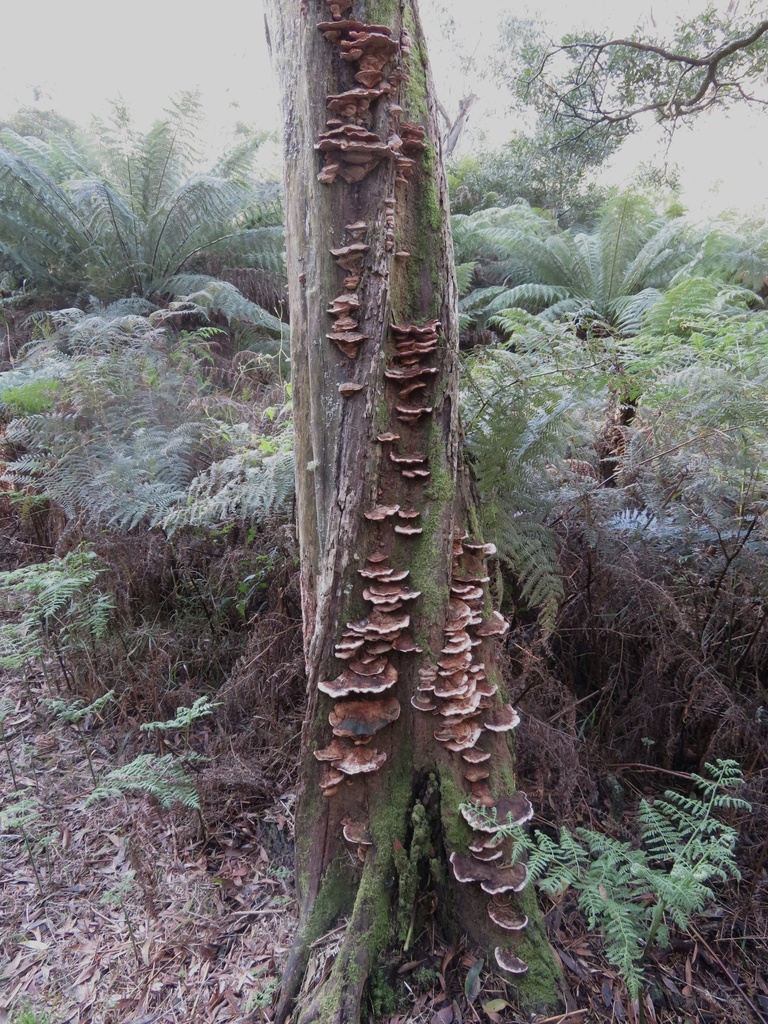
[462,331,596,631]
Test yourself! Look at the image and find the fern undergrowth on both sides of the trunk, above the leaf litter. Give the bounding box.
[0,97,768,1020]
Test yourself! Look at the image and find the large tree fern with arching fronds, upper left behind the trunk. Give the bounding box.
[0,93,283,323]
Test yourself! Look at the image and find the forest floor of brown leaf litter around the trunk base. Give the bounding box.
[0,663,768,1024]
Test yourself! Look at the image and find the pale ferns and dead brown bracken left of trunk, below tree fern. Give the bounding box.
[0,305,301,802]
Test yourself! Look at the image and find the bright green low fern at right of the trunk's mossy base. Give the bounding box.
[474,759,751,998]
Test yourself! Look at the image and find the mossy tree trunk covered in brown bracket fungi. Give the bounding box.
[267,0,555,1024]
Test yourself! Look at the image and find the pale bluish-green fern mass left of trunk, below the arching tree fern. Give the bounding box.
[0,309,293,531]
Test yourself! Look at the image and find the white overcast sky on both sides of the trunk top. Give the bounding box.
[0,0,768,215]
